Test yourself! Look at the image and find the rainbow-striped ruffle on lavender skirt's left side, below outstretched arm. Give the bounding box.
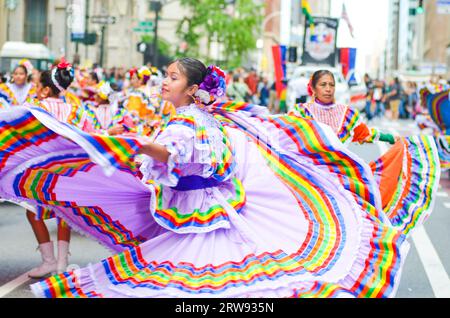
[0,107,145,250]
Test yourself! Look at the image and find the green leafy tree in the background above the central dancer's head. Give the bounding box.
[177,0,263,68]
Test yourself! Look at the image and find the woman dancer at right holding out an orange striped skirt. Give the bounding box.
[291,70,439,232]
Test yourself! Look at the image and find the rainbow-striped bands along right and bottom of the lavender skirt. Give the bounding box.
[32,105,408,297]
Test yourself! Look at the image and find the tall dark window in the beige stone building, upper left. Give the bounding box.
[25,0,47,43]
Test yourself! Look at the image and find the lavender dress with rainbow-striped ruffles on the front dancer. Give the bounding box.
[0,103,440,298]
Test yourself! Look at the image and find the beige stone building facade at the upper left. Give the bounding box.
[0,0,192,67]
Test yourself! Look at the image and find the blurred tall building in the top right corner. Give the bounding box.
[386,0,450,76]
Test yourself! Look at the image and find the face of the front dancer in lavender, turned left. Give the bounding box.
[161,62,198,107]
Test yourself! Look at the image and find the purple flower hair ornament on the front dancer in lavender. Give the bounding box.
[194,65,226,106]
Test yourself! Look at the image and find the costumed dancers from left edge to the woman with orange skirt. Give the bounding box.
[0,58,440,297]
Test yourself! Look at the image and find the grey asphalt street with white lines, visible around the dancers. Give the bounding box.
[0,119,450,298]
